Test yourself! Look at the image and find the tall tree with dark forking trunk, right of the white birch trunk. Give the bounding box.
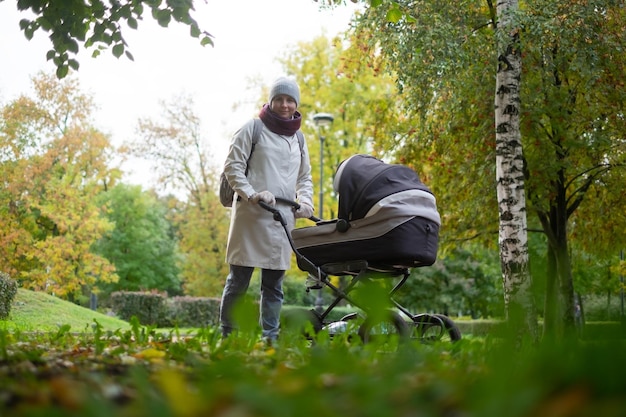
[522,0,626,335]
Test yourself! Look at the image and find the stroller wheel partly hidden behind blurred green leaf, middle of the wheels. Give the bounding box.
[359,310,409,350]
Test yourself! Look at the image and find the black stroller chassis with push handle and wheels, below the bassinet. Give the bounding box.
[259,198,461,343]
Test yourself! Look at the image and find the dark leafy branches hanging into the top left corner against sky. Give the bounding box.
[0,0,213,78]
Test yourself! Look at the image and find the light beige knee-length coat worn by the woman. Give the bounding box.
[224,120,313,270]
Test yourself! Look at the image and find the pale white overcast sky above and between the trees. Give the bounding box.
[0,0,356,188]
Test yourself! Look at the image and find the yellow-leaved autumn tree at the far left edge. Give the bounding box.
[0,74,119,297]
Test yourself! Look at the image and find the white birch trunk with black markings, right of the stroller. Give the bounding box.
[495,0,537,342]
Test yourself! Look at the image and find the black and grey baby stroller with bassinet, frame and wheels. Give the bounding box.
[263,155,461,343]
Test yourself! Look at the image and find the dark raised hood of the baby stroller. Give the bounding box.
[333,155,439,221]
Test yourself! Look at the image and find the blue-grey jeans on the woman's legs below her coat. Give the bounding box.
[220,265,285,339]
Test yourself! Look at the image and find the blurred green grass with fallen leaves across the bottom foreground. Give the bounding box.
[0,290,626,417]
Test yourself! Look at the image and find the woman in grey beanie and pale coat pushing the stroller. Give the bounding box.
[220,77,313,341]
